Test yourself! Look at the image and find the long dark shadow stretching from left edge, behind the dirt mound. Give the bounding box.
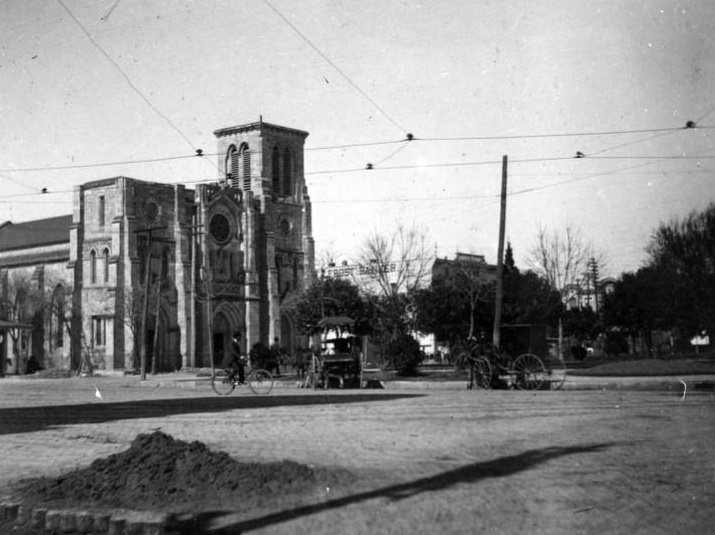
[0,393,420,435]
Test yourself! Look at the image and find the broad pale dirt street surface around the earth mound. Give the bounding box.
[0,378,715,535]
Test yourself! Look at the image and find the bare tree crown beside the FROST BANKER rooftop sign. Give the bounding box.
[358,224,433,297]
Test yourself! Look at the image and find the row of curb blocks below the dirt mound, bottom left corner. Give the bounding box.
[0,502,170,535]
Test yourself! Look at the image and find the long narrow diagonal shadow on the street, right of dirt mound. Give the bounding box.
[166,444,613,535]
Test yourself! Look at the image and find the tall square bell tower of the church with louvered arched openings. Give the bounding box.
[214,119,315,351]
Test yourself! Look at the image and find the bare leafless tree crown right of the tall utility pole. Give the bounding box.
[527,225,606,296]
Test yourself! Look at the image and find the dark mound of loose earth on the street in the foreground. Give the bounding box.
[19,431,342,510]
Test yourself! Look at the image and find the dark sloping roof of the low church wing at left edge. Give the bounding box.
[0,215,72,251]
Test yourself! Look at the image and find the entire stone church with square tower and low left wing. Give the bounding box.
[0,121,314,373]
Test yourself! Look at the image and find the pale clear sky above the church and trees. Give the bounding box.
[0,0,715,276]
